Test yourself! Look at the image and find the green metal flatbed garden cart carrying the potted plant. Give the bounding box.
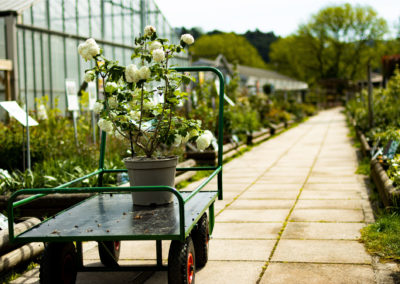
[7,67,224,284]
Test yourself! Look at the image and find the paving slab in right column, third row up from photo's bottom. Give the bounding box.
[282,222,365,240]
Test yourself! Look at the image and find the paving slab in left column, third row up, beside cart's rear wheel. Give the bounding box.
[212,222,283,240]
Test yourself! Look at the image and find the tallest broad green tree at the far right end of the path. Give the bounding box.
[270,4,388,84]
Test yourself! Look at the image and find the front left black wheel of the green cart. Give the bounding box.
[39,243,77,284]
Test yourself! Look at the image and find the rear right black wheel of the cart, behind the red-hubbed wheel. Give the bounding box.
[191,213,210,268]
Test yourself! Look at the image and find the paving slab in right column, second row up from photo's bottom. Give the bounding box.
[272,240,371,264]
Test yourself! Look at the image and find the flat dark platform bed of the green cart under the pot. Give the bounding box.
[16,191,218,242]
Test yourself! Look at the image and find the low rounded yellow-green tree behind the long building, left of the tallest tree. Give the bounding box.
[190,33,266,68]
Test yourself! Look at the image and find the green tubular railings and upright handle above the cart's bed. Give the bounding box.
[7,67,224,245]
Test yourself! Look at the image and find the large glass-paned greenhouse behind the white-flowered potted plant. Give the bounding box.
[0,0,187,114]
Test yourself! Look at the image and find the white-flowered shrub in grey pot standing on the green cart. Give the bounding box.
[78,26,212,205]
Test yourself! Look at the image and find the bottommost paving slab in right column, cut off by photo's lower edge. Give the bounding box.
[260,263,375,284]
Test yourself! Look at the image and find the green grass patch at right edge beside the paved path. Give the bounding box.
[361,213,400,261]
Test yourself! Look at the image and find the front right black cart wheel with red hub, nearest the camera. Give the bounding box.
[168,237,196,284]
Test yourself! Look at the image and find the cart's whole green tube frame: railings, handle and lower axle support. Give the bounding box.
[7,66,225,271]
